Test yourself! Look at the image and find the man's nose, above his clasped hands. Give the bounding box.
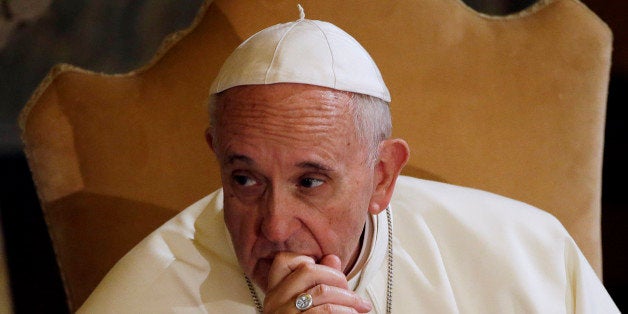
[261,187,301,243]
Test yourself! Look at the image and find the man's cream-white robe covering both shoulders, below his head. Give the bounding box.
[79,177,619,313]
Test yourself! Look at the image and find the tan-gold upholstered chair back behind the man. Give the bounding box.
[21,0,612,309]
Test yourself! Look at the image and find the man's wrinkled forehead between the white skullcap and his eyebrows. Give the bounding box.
[213,83,356,147]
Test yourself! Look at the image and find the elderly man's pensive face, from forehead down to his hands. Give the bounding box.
[213,84,374,290]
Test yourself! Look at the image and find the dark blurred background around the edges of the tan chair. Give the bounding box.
[0,0,628,314]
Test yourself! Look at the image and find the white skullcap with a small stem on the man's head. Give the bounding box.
[210,7,390,102]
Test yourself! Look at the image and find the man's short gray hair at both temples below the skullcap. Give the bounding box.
[208,93,392,167]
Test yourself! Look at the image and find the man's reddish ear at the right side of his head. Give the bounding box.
[369,139,410,215]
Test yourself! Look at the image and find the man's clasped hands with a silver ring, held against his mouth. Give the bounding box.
[264,252,372,313]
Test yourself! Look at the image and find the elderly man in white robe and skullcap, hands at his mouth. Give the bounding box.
[79,8,619,313]
